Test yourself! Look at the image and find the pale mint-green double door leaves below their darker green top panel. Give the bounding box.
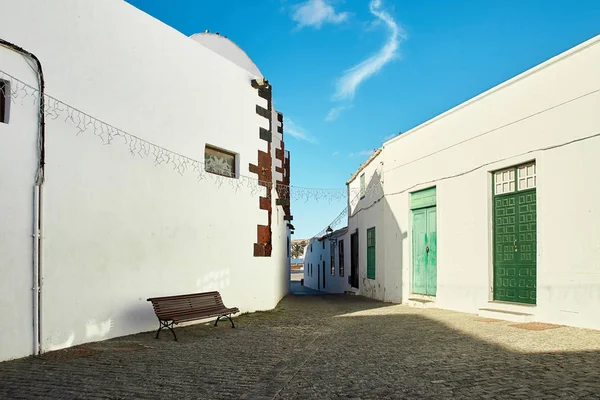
[412,207,437,296]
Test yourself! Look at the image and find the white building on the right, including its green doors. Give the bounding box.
[338,36,600,329]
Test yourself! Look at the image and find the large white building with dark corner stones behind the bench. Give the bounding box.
[0,0,291,361]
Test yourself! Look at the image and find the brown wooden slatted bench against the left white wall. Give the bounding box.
[147,292,240,340]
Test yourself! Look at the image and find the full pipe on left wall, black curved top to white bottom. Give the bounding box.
[0,39,46,355]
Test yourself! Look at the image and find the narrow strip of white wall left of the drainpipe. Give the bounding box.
[0,49,38,361]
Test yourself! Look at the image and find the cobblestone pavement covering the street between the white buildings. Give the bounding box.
[0,295,600,399]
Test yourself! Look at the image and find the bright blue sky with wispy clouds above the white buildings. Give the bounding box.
[128,0,600,239]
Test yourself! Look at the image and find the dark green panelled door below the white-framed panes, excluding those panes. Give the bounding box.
[494,189,537,304]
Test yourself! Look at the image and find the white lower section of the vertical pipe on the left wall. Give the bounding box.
[33,185,44,355]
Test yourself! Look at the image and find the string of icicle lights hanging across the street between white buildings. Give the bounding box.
[0,70,356,203]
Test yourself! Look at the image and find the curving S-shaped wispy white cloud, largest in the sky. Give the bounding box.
[334,0,406,99]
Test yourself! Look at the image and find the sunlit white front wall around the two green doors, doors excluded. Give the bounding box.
[382,36,600,329]
